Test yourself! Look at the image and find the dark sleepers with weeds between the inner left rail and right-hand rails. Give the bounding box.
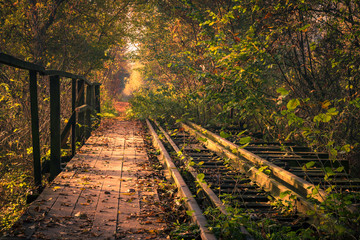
[145,121,322,239]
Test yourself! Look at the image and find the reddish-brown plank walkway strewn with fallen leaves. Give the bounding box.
[7,121,166,239]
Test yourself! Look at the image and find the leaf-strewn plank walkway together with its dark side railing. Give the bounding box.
[0,53,165,239]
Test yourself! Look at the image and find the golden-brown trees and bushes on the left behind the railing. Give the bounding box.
[0,0,130,234]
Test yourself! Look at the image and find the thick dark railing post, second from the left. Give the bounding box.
[50,75,61,180]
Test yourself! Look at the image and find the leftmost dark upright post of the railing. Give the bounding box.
[29,70,41,186]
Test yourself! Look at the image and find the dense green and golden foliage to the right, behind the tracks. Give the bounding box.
[131,0,360,176]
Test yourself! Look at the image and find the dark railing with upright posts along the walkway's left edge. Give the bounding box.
[0,53,101,186]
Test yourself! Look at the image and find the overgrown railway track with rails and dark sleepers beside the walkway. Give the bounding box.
[148,119,360,239]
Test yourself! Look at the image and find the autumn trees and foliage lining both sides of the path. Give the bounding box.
[0,0,360,236]
